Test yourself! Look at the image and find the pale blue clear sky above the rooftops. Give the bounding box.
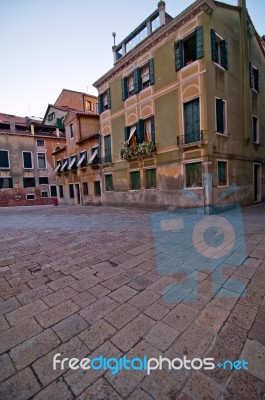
[0,0,265,116]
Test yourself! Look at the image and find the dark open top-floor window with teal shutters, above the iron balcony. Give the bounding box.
[175,26,203,71]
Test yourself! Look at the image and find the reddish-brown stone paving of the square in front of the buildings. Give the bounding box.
[0,204,265,400]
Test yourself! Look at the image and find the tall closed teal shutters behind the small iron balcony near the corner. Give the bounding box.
[184,99,201,144]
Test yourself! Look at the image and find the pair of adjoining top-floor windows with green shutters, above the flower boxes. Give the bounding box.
[121,58,155,100]
